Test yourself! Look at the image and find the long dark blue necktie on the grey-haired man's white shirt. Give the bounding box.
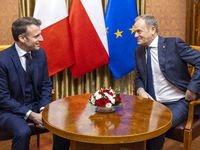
[147,47,156,100]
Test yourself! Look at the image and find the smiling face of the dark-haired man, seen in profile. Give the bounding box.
[24,24,44,52]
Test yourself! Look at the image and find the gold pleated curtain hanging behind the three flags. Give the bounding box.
[19,0,145,99]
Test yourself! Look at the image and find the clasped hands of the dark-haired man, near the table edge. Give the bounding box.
[28,112,45,129]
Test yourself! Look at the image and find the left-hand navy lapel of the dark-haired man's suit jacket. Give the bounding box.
[11,45,25,96]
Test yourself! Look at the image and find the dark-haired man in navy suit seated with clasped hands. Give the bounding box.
[0,17,67,150]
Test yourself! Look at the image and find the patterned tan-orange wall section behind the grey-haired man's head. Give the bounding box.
[146,0,186,41]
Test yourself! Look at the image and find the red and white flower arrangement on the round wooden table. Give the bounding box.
[89,86,122,108]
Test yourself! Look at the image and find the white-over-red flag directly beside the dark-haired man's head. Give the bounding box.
[33,0,75,76]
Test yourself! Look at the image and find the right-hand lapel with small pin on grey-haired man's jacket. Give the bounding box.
[158,36,167,72]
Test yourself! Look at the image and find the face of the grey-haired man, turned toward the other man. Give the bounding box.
[134,18,156,47]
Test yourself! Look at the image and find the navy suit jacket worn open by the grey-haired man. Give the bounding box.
[134,37,200,94]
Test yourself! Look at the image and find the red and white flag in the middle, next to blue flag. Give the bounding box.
[69,0,109,78]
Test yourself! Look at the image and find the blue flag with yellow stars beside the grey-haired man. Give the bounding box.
[105,0,138,80]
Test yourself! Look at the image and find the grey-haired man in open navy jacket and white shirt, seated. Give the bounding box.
[134,14,200,150]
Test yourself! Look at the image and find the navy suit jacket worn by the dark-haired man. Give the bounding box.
[0,44,52,128]
